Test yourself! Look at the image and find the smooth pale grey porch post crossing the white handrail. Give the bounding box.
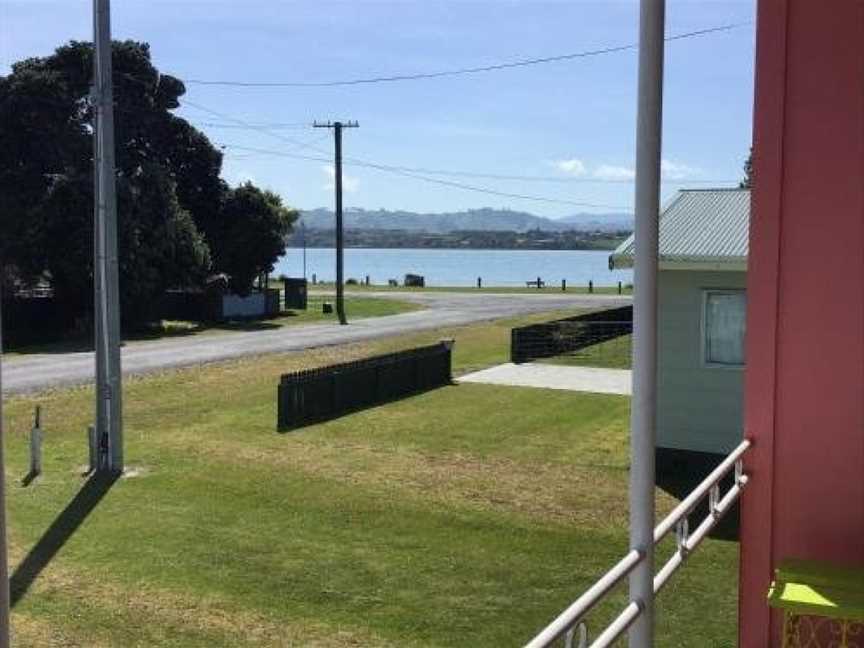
[629,0,666,648]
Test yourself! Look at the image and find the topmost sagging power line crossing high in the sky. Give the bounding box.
[183,21,752,88]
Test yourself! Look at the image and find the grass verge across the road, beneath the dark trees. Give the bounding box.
[3,295,423,356]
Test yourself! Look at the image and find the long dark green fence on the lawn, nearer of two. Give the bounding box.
[277,341,453,430]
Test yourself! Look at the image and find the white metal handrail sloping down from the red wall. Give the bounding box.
[525,439,752,648]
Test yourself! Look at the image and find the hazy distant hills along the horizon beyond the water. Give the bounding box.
[301,207,633,234]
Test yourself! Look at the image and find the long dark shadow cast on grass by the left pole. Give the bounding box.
[9,473,120,607]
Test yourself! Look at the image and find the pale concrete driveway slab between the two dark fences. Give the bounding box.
[459,362,630,396]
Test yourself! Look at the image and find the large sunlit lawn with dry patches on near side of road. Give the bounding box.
[5,314,737,648]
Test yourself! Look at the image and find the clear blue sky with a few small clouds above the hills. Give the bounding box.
[0,0,754,217]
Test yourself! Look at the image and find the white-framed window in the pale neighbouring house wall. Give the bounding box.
[704,290,747,367]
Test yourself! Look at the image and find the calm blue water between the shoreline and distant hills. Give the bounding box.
[274,248,633,286]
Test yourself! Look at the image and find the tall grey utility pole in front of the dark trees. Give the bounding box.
[93,0,123,472]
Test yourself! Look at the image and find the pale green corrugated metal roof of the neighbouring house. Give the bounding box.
[609,189,750,269]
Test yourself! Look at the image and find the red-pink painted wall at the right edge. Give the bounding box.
[739,0,864,648]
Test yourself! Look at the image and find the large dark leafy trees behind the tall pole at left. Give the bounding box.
[0,41,296,320]
